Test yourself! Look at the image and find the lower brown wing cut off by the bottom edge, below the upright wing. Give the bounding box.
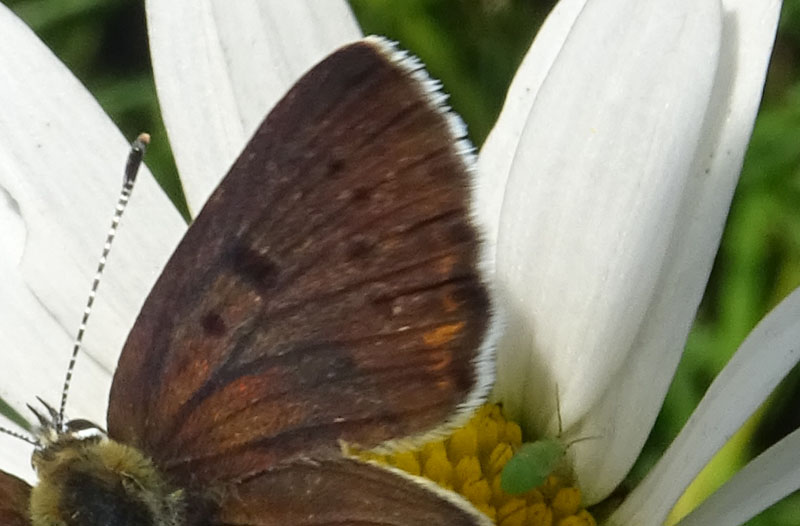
[212,460,492,526]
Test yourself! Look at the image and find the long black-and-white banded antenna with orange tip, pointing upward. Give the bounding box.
[56,133,150,430]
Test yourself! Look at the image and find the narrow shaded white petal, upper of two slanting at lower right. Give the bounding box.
[612,289,800,526]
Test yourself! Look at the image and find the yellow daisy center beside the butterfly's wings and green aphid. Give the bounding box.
[359,404,597,526]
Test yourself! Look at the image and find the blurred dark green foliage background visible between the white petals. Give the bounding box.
[0,0,800,525]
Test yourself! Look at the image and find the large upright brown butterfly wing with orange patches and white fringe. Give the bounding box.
[108,39,491,482]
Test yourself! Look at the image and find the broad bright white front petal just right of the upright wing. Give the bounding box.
[497,0,720,495]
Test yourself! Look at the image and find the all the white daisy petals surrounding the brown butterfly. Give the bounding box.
[0,0,800,525]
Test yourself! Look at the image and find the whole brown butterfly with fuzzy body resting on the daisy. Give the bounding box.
[0,37,494,526]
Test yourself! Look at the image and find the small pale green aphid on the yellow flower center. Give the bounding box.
[500,438,567,495]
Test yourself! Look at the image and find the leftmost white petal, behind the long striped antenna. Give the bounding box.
[0,7,185,477]
